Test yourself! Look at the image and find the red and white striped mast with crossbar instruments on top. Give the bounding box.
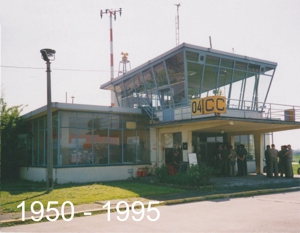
[100,8,122,107]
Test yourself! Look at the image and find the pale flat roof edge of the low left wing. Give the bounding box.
[21,102,142,120]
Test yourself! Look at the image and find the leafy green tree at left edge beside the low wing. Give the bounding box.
[0,98,24,180]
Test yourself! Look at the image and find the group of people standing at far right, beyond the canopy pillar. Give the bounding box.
[265,144,294,178]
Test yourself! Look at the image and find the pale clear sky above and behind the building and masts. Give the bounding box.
[0,0,300,149]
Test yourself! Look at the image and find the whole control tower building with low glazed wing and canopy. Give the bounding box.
[20,43,300,183]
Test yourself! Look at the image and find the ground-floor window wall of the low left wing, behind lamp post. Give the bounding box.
[26,110,150,166]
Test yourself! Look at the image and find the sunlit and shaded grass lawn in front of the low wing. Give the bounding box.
[1,181,185,213]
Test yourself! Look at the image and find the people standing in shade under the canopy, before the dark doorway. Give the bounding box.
[217,144,248,176]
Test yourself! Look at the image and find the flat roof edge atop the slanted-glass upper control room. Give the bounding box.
[100,43,277,89]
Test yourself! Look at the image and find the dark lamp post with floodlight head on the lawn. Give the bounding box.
[40,49,55,192]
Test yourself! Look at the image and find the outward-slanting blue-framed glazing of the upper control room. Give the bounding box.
[101,45,277,114]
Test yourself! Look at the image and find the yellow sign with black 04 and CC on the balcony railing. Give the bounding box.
[191,95,226,116]
